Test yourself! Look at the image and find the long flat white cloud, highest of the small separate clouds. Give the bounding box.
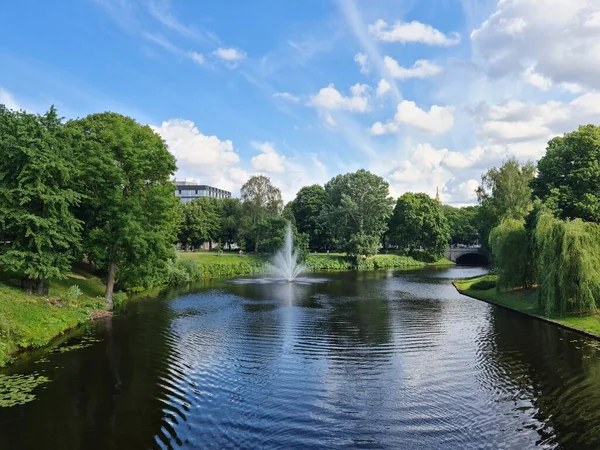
[369,19,460,46]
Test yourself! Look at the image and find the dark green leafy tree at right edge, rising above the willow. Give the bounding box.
[532,125,600,223]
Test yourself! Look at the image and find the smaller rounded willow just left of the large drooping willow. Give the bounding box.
[489,219,532,289]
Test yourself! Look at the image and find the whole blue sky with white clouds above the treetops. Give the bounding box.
[0,0,600,205]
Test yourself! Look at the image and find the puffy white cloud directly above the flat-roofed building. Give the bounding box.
[151,119,247,190]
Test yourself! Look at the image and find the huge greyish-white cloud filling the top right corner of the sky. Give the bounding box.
[471,0,600,89]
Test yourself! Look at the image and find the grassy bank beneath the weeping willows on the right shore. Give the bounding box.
[454,275,600,338]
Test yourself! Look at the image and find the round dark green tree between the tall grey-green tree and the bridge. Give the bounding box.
[389,192,450,261]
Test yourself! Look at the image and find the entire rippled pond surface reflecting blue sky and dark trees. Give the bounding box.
[0,268,600,449]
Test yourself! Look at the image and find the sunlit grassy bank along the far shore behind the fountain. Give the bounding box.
[179,251,426,278]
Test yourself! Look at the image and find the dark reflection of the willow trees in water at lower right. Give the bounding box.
[478,308,600,449]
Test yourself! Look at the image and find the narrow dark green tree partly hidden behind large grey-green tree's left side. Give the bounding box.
[292,184,327,249]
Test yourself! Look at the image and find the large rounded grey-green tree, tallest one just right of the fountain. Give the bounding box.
[320,169,393,256]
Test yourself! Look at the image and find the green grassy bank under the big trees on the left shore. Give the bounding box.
[0,270,104,367]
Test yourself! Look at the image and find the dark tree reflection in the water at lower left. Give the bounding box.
[0,292,178,449]
